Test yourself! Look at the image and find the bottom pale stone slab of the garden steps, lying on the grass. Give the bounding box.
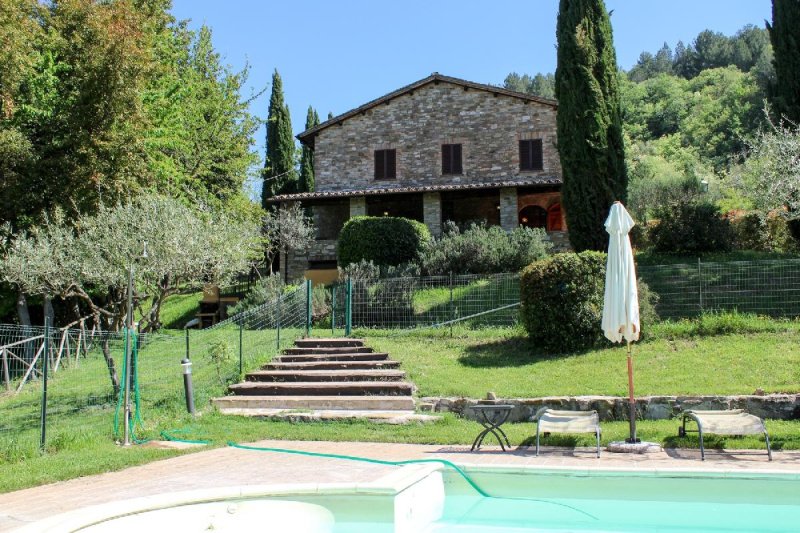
[220,407,442,424]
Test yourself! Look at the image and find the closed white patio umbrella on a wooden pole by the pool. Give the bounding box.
[601,202,640,443]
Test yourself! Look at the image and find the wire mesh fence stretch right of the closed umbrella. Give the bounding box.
[638,259,800,319]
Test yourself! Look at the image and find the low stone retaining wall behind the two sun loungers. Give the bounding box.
[420,394,800,422]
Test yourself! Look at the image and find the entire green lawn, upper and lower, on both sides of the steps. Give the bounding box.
[0,317,800,492]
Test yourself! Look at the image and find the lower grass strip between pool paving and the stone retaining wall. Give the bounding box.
[0,413,800,493]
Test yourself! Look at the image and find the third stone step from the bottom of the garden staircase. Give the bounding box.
[228,381,414,396]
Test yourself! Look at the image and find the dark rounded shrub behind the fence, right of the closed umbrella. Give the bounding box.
[650,202,733,255]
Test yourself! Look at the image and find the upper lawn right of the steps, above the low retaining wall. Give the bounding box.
[366,323,800,398]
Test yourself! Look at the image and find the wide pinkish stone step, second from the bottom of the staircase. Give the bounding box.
[211,396,414,412]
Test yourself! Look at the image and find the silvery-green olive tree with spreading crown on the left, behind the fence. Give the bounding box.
[0,195,260,390]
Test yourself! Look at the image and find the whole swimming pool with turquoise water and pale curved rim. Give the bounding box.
[18,465,800,533]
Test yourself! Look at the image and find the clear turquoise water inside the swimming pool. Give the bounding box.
[290,470,800,533]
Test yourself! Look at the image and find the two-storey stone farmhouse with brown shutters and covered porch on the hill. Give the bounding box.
[272,73,567,283]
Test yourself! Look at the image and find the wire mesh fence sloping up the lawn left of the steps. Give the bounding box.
[0,286,309,454]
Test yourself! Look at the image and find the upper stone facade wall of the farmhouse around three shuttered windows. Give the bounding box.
[314,82,561,191]
